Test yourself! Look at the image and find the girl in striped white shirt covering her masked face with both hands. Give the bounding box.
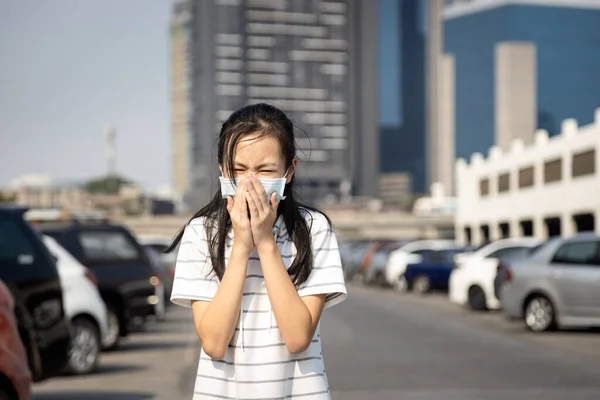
[171,104,346,400]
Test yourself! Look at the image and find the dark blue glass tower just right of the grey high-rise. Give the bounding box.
[379,0,427,193]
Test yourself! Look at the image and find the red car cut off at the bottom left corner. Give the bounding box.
[0,281,31,400]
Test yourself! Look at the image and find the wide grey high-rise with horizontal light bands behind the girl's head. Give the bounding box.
[187,0,378,207]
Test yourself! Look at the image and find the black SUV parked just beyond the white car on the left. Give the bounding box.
[38,221,162,349]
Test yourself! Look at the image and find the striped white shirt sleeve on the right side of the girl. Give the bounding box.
[298,213,347,308]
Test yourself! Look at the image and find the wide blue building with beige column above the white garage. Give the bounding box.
[444,0,600,162]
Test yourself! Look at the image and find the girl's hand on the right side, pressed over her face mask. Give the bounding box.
[246,174,277,249]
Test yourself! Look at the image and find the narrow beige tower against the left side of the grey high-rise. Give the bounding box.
[170,0,191,203]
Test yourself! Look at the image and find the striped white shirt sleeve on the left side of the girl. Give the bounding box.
[171,221,219,307]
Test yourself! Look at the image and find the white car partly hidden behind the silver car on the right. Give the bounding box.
[448,238,541,311]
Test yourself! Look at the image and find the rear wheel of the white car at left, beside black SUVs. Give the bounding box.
[67,318,101,375]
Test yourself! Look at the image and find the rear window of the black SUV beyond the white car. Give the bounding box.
[79,231,141,261]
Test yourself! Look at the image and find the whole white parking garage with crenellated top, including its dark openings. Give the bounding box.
[455,108,600,244]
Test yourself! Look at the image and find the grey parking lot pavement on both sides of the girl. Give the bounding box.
[33,285,600,400]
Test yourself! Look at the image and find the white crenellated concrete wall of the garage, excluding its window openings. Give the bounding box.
[455,108,600,243]
